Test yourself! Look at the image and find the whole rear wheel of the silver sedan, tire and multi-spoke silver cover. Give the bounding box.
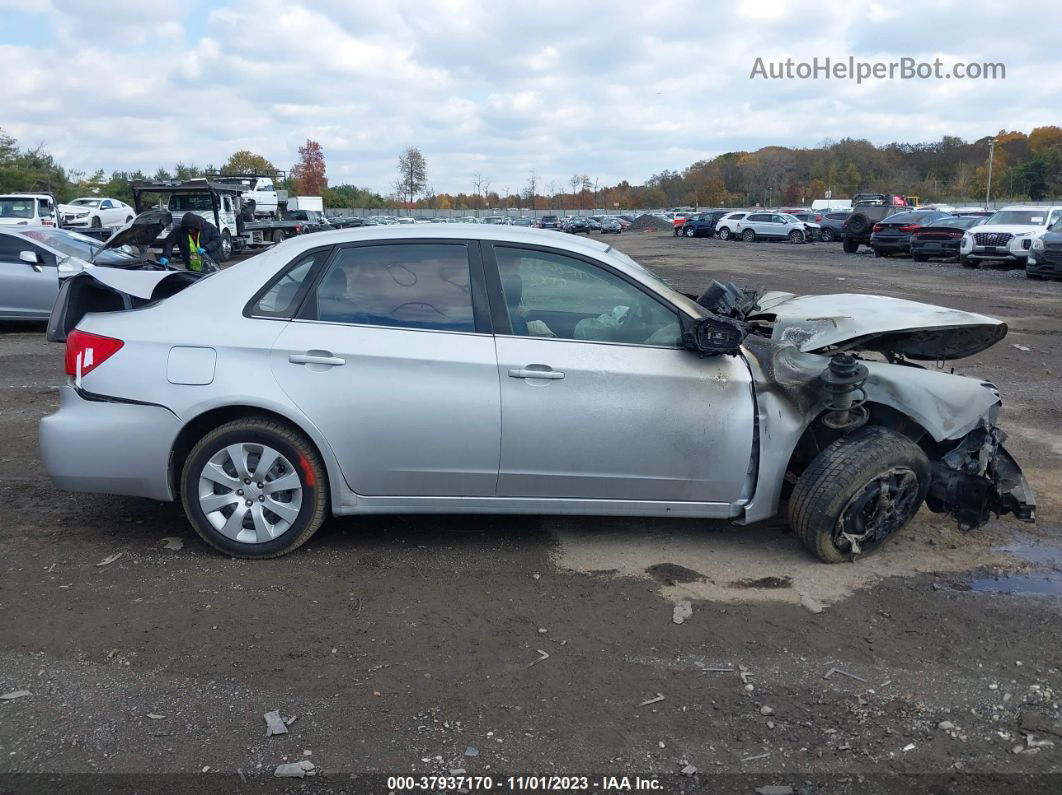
[181,417,328,558]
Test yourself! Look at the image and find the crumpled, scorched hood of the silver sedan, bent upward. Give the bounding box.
[746,293,1007,361]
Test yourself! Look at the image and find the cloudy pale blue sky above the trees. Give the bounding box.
[0,0,1062,192]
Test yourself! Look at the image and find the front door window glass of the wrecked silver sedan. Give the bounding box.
[494,246,682,347]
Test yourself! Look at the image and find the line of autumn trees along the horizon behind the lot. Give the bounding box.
[0,126,1062,210]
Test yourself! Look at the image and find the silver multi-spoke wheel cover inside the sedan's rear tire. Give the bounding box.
[199,443,303,543]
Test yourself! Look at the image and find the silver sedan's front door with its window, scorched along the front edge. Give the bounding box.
[489,244,754,503]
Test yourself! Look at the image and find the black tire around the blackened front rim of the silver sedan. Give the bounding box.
[789,428,929,564]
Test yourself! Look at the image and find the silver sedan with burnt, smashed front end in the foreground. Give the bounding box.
[40,225,1034,563]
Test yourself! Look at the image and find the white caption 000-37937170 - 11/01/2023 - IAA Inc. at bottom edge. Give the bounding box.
[387,773,663,792]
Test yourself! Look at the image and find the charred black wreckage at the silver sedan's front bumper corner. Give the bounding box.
[926,417,1037,531]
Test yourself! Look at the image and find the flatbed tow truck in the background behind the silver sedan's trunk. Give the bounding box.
[130,178,304,260]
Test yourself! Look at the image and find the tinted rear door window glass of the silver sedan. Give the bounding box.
[314,243,476,331]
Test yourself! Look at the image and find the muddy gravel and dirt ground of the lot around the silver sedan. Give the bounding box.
[0,234,1062,792]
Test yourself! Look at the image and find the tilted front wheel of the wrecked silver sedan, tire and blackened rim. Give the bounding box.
[789,428,929,564]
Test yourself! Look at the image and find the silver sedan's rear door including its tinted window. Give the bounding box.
[271,240,501,497]
